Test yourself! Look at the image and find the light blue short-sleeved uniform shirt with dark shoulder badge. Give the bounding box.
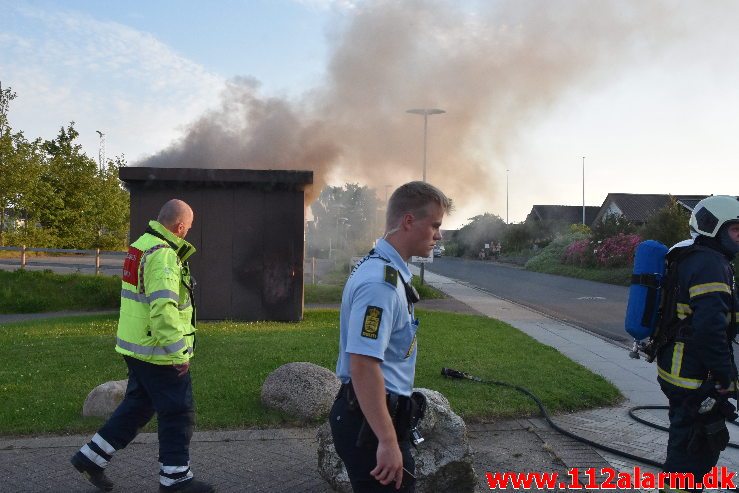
[336,239,418,395]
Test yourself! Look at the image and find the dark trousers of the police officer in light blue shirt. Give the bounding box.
[329,396,416,493]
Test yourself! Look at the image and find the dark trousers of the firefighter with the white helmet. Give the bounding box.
[660,381,720,491]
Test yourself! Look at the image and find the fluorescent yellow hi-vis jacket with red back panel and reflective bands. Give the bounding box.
[115,221,196,365]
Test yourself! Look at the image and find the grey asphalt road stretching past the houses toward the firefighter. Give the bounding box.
[426,257,632,346]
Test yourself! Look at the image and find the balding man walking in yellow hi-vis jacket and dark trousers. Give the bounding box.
[72,199,215,493]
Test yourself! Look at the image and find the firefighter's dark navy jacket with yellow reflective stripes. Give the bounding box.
[657,240,739,390]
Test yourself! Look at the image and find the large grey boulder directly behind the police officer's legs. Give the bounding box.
[317,388,477,493]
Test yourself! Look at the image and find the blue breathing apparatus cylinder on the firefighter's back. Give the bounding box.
[625,240,667,342]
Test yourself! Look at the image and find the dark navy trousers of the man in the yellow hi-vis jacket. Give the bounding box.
[98,356,195,466]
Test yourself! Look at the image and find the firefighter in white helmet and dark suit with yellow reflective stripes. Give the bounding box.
[657,195,739,491]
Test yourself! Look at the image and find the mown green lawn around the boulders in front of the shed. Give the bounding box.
[0,310,620,435]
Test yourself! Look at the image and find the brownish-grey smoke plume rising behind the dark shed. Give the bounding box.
[138,0,679,209]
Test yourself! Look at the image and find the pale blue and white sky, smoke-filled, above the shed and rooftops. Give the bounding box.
[0,0,739,228]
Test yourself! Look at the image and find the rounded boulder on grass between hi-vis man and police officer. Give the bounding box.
[262,362,341,421]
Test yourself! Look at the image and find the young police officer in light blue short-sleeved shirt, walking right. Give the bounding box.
[330,181,451,492]
